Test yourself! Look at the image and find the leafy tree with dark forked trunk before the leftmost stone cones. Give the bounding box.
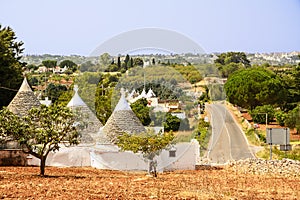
[0,105,79,175]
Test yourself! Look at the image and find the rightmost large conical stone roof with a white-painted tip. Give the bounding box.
[103,89,146,143]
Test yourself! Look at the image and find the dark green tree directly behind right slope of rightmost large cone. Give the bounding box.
[130,98,151,126]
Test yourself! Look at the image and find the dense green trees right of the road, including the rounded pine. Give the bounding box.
[223,51,300,132]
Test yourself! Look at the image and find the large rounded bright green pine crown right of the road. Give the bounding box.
[225,68,286,109]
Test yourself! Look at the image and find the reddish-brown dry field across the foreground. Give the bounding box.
[0,167,300,199]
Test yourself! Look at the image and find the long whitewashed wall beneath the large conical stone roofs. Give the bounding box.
[28,140,200,171]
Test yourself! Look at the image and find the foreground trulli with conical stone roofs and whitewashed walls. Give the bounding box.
[5,79,200,170]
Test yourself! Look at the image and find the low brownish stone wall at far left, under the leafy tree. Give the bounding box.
[0,149,27,166]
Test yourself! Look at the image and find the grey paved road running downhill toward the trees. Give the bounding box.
[207,103,254,164]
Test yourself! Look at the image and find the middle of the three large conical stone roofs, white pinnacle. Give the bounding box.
[67,85,103,143]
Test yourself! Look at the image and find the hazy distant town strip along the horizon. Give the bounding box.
[22,51,300,65]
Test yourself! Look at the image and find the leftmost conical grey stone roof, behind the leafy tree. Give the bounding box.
[7,78,41,116]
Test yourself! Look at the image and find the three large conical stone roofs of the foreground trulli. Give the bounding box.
[8,78,145,144]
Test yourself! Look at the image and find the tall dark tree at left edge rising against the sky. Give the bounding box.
[0,24,25,108]
